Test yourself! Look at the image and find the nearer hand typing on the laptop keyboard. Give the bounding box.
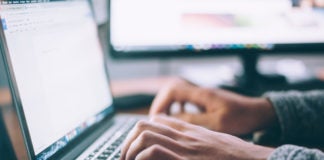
[121,116,273,160]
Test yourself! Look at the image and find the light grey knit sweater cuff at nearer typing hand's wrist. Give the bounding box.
[268,145,324,160]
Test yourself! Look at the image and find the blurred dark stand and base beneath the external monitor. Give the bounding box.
[221,53,324,96]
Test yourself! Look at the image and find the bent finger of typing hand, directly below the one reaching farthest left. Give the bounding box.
[126,131,185,160]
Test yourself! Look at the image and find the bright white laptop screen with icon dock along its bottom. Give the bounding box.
[0,0,112,159]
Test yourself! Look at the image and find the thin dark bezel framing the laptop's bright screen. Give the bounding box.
[0,0,119,159]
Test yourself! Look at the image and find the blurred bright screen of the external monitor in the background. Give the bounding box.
[110,0,324,56]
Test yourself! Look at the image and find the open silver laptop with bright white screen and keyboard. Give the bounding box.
[0,0,145,159]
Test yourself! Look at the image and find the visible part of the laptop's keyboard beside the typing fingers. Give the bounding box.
[85,119,138,160]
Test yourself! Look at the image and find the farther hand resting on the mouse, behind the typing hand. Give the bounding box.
[150,79,276,135]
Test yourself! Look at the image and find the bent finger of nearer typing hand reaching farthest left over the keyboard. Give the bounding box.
[121,121,180,159]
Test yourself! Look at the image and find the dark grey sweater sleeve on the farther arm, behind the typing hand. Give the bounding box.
[265,90,324,143]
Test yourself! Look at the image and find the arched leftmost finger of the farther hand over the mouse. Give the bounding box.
[150,85,212,115]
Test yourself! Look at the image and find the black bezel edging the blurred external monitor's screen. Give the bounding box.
[107,1,324,59]
